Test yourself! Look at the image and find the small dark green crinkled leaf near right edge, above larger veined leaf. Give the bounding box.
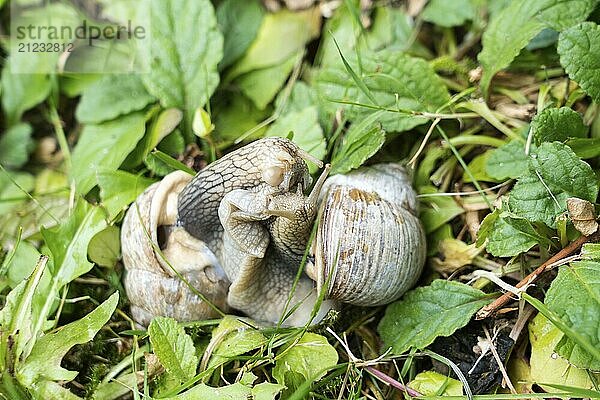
[531,107,588,145]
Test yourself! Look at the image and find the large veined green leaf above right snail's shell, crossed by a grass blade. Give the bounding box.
[315,50,450,132]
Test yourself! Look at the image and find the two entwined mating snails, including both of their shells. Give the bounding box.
[121,138,425,326]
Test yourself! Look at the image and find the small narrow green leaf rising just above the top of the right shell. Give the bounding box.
[331,112,385,175]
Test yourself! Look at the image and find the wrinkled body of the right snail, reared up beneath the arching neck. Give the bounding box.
[219,167,333,326]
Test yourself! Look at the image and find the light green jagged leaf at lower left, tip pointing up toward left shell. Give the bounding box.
[17,292,119,385]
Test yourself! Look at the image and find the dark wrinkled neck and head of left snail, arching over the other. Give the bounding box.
[178,137,320,256]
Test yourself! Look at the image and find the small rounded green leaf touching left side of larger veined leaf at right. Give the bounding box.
[486,140,529,180]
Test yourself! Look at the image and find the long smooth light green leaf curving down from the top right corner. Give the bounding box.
[477,0,598,93]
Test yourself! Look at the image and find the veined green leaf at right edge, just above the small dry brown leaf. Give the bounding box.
[508,142,598,227]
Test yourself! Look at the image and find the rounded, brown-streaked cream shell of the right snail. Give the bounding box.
[307,164,426,306]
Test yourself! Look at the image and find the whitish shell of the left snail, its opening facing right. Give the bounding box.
[121,171,229,325]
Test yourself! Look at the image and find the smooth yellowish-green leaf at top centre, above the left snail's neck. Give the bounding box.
[226,7,321,80]
